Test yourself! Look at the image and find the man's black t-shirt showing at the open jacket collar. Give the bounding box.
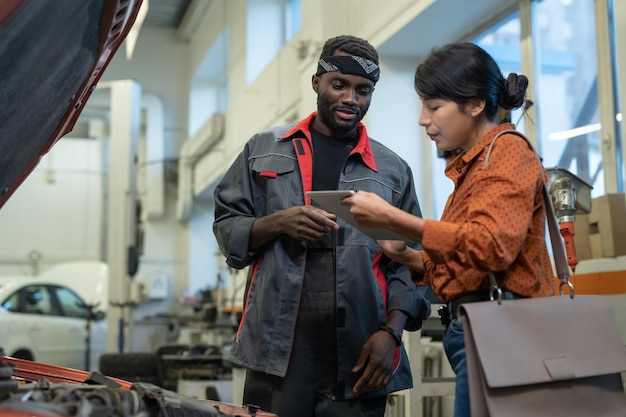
[311,129,357,190]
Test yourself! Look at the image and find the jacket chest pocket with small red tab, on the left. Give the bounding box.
[250,154,304,214]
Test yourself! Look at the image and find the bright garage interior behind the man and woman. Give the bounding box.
[0,0,626,417]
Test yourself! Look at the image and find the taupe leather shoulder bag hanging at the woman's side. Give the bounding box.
[459,129,626,417]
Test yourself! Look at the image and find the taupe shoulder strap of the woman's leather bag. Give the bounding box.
[483,129,574,301]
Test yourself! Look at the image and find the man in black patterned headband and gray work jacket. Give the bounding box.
[213,36,430,417]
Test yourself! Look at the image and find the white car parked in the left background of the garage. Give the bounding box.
[0,263,107,370]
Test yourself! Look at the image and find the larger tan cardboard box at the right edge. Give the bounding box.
[574,193,626,259]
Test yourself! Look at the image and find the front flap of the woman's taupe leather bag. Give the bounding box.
[459,295,626,388]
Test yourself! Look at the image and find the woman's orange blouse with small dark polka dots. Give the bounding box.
[414,123,555,302]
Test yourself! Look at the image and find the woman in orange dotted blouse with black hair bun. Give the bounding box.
[344,43,556,417]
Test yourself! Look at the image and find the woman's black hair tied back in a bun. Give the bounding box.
[415,42,528,121]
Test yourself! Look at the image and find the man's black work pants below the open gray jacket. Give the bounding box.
[243,250,386,417]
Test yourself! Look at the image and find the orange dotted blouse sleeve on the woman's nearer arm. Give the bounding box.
[422,134,541,279]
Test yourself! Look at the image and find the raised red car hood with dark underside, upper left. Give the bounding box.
[0,0,142,208]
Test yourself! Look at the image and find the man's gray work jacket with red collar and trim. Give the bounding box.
[213,113,430,398]
